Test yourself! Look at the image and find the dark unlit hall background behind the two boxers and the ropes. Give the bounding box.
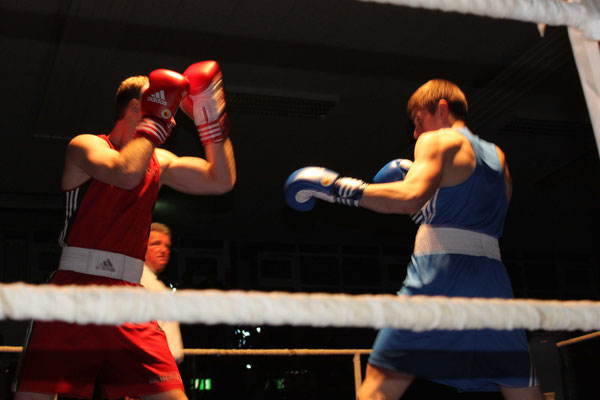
[0,0,600,398]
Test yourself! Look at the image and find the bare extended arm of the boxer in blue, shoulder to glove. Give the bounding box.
[360,134,449,214]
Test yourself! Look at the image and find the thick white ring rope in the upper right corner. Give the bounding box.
[359,0,600,40]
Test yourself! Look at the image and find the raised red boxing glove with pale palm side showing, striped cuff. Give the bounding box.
[181,61,229,146]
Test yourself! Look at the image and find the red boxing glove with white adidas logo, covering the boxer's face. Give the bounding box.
[135,69,190,147]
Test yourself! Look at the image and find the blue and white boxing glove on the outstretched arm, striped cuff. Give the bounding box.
[283,167,368,211]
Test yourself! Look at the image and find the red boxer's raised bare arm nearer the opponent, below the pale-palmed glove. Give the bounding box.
[156,139,236,194]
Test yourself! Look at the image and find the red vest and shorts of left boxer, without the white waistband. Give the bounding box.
[13,135,183,398]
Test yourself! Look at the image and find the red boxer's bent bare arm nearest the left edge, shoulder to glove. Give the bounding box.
[62,134,154,190]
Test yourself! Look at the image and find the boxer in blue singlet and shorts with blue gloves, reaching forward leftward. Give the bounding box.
[284,79,543,400]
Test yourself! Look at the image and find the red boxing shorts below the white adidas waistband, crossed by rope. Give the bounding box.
[14,270,184,398]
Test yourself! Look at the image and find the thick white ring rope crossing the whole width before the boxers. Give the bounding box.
[0,283,600,331]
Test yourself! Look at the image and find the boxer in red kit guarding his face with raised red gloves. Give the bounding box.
[13,61,236,400]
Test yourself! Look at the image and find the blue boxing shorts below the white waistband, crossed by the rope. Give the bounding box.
[369,254,538,391]
